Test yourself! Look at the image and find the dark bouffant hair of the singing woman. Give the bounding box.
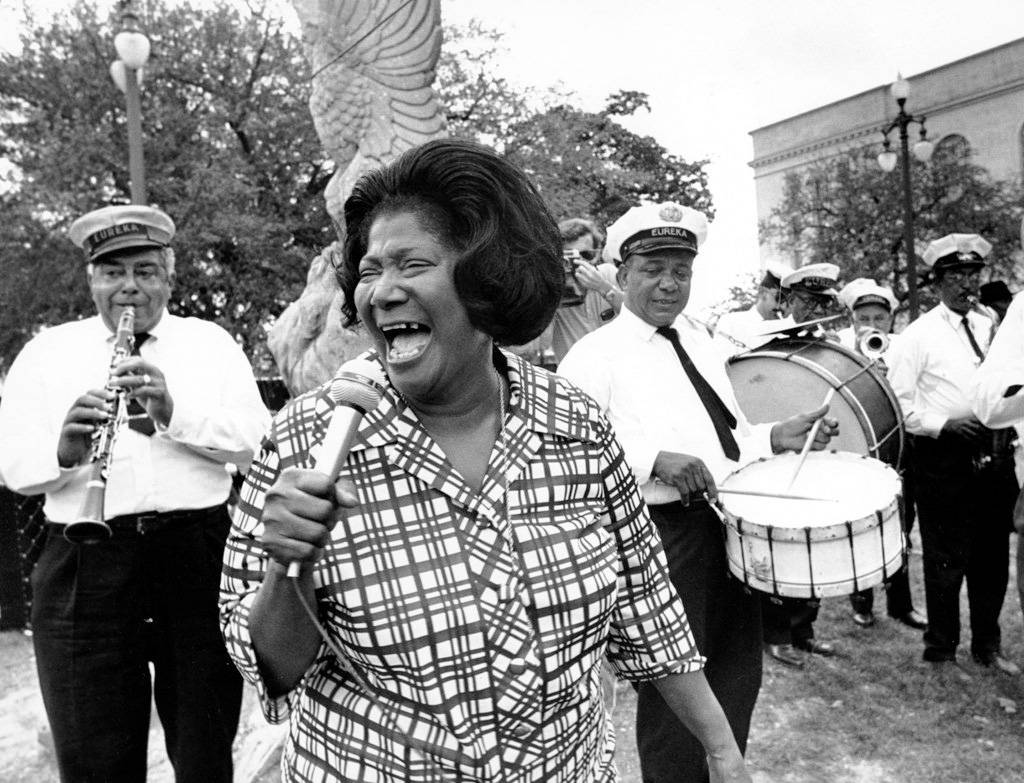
[338,139,564,345]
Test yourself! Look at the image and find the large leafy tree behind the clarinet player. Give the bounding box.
[0,0,333,367]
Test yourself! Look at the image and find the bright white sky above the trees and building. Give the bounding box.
[6,0,1024,309]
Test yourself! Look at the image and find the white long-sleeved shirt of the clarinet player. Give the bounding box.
[0,312,270,523]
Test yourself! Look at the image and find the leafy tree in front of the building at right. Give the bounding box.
[760,148,1024,306]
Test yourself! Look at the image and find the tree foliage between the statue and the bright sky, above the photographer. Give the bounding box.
[438,23,715,225]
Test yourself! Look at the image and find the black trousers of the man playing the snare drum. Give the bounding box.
[637,502,762,783]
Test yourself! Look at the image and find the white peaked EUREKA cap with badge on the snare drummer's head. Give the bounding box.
[605,202,708,263]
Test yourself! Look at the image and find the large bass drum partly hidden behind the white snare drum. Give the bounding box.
[727,337,903,469]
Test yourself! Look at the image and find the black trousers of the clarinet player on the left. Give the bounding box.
[32,507,242,783]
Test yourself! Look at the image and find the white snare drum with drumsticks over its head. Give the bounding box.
[719,451,905,598]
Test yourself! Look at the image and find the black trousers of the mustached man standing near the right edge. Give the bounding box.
[914,435,1017,660]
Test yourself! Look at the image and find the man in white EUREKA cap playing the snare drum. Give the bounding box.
[559,202,838,783]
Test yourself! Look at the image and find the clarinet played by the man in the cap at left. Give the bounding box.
[65,306,135,543]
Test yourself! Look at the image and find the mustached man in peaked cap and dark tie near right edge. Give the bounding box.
[889,233,1020,673]
